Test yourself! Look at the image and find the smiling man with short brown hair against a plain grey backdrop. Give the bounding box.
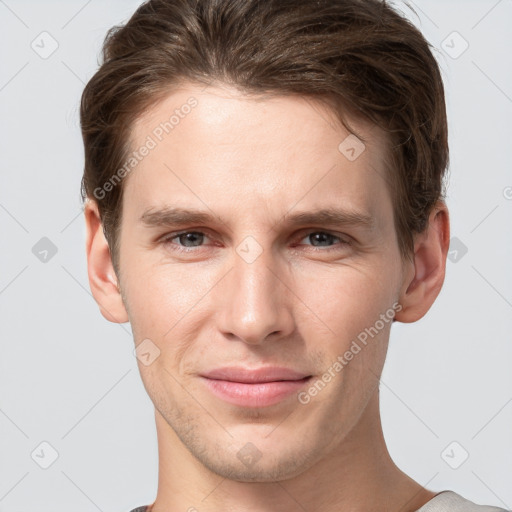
[81,0,508,512]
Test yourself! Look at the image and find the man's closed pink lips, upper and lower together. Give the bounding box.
[200,367,311,407]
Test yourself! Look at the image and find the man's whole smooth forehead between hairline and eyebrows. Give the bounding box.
[123,84,389,226]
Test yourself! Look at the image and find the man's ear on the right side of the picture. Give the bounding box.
[395,201,450,323]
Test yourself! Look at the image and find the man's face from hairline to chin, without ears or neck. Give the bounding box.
[119,84,404,481]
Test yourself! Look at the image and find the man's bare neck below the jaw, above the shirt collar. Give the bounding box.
[150,389,436,512]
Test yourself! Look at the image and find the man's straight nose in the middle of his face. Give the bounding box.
[214,241,294,345]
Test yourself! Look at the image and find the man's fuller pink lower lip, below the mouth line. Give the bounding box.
[201,377,311,407]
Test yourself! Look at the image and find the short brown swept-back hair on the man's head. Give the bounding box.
[80,0,448,272]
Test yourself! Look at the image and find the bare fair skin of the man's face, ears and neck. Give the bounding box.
[85,83,449,512]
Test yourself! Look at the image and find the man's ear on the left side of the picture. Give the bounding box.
[84,199,129,324]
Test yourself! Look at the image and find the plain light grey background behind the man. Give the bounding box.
[0,0,512,512]
